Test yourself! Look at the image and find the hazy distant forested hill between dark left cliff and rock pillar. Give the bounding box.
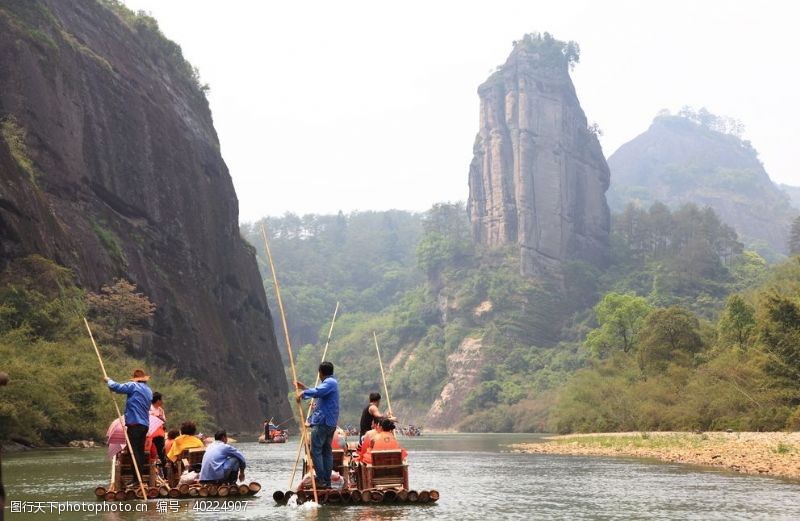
[241,210,422,354]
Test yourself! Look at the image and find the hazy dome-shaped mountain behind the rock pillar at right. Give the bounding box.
[608,116,797,254]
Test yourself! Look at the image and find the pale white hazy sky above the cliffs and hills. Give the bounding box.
[125,0,800,221]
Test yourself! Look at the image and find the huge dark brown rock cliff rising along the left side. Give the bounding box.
[0,0,291,429]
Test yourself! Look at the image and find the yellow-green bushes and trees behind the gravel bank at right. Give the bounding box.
[550,257,800,432]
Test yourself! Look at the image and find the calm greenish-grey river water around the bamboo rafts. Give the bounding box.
[3,434,800,521]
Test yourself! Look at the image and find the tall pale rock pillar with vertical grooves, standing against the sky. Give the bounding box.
[468,38,610,274]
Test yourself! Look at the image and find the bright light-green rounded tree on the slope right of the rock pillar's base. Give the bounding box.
[586,293,652,357]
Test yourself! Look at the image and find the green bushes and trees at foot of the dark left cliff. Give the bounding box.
[0,255,209,444]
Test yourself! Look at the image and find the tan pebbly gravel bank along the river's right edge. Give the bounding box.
[511,432,800,479]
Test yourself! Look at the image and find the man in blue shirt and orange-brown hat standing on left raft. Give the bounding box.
[105,369,153,487]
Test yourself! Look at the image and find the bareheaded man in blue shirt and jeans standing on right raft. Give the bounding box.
[295,362,339,488]
